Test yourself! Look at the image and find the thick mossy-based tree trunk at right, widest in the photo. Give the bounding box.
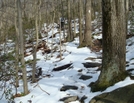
[91,0,127,91]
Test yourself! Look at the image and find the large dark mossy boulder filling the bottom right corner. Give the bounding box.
[89,84,134,103]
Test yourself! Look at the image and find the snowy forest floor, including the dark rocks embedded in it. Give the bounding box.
[0,22,134,103]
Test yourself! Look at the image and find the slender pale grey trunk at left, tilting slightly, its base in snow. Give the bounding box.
[17,0,28,94]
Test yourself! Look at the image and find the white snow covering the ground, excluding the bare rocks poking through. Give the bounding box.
[0,24,134,103]
